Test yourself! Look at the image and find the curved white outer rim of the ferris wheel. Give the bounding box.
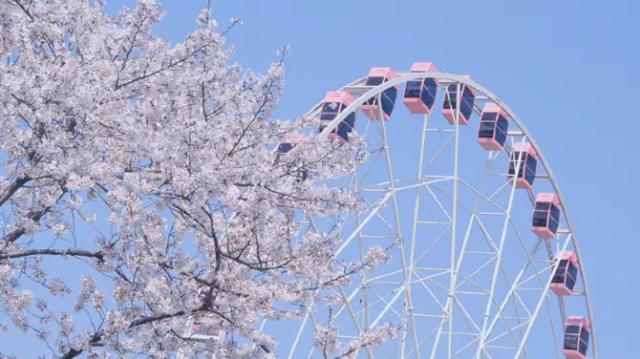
[284,71,598,359]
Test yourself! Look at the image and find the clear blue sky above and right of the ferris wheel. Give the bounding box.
[6,0,640,359]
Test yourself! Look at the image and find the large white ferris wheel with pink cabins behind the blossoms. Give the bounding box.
[262,63,598,358]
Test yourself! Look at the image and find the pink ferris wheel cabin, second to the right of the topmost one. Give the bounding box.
[478,102,509,151]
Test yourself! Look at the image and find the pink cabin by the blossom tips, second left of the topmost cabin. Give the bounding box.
[319,91,356,143]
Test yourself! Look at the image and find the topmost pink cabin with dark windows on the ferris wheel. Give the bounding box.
[402,62,438,113]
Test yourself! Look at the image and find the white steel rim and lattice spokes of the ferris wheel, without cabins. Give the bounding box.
[199,72,598,359]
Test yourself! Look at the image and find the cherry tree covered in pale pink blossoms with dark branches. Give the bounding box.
[0,0,391,358]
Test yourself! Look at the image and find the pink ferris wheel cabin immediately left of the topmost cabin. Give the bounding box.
[360,67,398,120]
